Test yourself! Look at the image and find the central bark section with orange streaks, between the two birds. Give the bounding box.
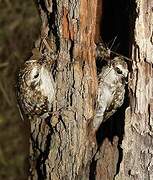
[29,0,97,180]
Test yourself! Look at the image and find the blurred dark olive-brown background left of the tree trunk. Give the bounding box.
[0,0,40,180]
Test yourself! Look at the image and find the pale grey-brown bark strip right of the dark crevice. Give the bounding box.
[115,0,153,180]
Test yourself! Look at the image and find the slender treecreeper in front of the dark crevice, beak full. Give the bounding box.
[93,44,129,129]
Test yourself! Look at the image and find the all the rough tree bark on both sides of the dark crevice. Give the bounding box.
[29,0,153,180]
